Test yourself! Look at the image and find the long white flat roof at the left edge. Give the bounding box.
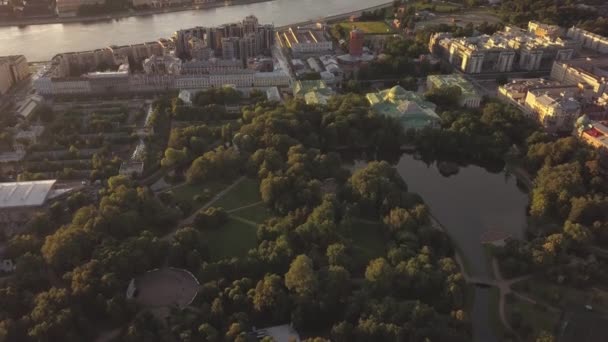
[0,179,56,208]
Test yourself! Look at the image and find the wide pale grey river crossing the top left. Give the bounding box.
[0,0,389,61]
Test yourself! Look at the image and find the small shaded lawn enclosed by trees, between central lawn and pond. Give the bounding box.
[350,220,386,269]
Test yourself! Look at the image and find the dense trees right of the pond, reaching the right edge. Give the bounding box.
[497,133,608,286]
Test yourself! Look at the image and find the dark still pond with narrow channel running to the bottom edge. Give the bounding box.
[355,154,528,342]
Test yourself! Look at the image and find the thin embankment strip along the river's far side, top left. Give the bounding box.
[0,0,274,27]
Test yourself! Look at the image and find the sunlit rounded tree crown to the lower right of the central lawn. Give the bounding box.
[285,254,318,298]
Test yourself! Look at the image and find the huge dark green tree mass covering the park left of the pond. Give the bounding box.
[0,94,470,341]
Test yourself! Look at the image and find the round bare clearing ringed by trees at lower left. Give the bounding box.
[135,268,200,308]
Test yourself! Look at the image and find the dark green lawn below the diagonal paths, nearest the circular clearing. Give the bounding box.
[204,218,257,261]
